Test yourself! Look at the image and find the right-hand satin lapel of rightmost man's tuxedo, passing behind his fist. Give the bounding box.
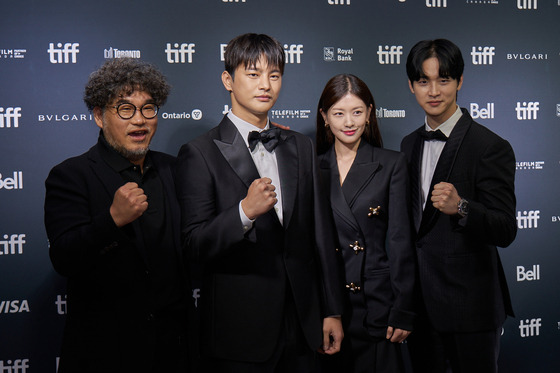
[419,111,472,235]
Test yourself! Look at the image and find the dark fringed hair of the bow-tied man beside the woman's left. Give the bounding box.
[224,34,286,77]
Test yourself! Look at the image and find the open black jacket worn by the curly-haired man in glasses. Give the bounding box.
[45,143,188,373]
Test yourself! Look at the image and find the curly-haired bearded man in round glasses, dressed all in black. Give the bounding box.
[45,59,192,373]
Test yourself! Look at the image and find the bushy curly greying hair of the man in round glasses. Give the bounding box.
[84,58,171,111]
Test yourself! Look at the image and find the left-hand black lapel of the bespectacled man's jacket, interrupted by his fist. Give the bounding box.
[89,144,148,265]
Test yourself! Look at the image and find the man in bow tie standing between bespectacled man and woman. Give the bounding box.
[177,34,343,373]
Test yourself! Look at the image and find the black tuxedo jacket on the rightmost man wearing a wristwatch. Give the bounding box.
[401,109,517,332]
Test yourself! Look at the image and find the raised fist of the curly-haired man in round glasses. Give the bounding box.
[109,183,148,228]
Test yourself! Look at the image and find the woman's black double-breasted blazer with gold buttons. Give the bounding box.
[319,141,416,339]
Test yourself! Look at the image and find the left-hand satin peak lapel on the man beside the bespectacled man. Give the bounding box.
[214,117,260,188]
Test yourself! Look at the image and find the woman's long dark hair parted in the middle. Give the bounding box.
[316,74,383,154]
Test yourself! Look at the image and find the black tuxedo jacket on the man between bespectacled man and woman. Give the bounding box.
[177,117,341,362]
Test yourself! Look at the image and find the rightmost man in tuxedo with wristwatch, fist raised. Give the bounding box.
[401,39,517,373]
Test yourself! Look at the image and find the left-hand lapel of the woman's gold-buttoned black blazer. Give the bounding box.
[319,147,359,231]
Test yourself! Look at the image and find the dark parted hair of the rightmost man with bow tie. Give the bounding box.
[406,39,465,82]
